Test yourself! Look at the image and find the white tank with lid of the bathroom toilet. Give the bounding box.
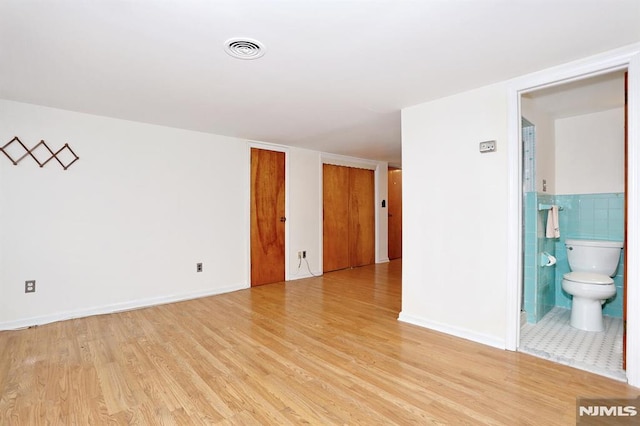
[564,239,623,277]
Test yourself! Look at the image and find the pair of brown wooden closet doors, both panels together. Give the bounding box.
[322,164,375,272]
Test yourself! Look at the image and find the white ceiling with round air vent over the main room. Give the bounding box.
[0,0,640,164]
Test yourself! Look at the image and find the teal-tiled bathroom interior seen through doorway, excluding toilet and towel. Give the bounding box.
[518,70,626,381]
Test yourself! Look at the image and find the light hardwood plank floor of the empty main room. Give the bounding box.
[0,261,640,425]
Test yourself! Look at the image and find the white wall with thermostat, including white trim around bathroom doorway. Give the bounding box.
[400,45,640,386]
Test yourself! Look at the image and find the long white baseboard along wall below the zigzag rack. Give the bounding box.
[0,285,248,331]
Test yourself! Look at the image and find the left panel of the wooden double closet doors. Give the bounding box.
[322,164,350,272]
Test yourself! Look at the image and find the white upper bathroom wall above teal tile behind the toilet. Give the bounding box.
[555,108,624,194]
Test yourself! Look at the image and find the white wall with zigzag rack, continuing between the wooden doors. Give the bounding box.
[0,100,387,330]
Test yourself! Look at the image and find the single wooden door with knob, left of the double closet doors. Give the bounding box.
[251,148,286,286]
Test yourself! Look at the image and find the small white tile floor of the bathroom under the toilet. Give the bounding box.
[518,307,627,382]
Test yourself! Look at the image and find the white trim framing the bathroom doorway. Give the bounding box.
[505,44,640,387]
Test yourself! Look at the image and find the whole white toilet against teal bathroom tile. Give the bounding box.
[562,239,623,331]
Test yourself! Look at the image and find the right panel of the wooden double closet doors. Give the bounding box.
[349,168,376,268]
